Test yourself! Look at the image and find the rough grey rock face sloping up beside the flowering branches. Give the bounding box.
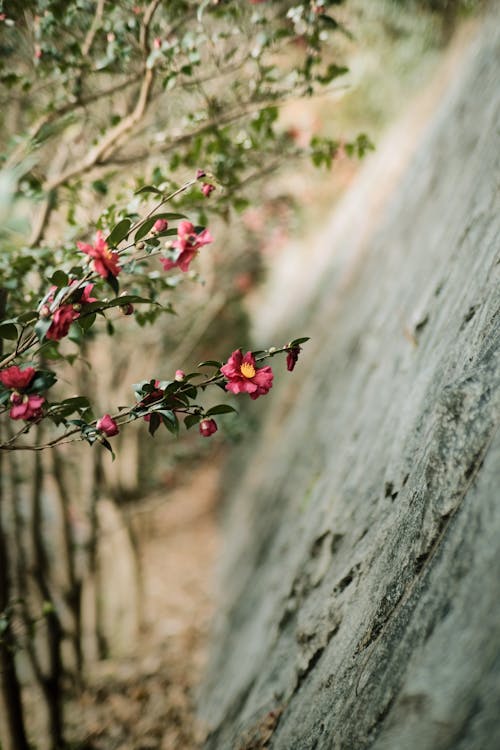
[200,19,500,750]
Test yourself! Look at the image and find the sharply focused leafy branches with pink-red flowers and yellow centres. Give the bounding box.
[0,164,306,450]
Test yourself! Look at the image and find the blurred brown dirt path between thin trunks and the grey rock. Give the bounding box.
[67,456,222,750]
